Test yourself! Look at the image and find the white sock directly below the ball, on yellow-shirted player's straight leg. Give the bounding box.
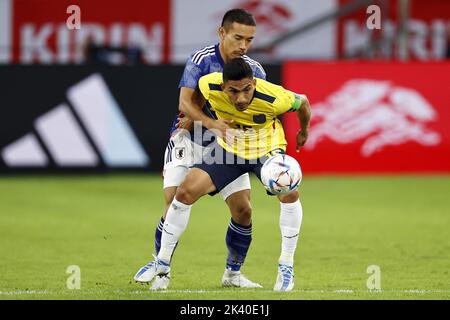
[278,200,303,266]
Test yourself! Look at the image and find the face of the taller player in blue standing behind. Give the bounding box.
[219,22,256,62]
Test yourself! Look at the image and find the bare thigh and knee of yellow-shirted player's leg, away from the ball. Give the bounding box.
[176,167,216,204]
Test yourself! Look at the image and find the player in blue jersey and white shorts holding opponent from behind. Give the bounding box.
[134,9,266,289]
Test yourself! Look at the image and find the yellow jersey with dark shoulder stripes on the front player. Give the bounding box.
[199,72,301,160]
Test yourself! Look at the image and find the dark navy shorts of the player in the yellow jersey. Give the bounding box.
[194,145,284,195]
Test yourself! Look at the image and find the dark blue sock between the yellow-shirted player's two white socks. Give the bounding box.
[226,219,252,271]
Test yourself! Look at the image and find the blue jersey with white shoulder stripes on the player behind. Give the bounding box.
[170,44,266,134]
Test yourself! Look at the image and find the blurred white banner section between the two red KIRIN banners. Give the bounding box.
[170,0,338,63]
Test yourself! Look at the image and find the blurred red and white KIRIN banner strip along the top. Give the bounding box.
[0,0,450,65]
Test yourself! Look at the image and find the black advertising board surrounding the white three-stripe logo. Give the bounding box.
[0,65,281,173]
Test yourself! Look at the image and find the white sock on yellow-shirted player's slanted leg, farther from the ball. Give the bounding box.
[158,198,192,263]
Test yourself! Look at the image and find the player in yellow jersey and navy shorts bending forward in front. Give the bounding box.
[146,58,311,291]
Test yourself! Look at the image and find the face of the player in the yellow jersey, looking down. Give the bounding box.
[222,78,256,111]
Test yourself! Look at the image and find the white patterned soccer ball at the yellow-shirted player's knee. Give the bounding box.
[261,154,302,194]
